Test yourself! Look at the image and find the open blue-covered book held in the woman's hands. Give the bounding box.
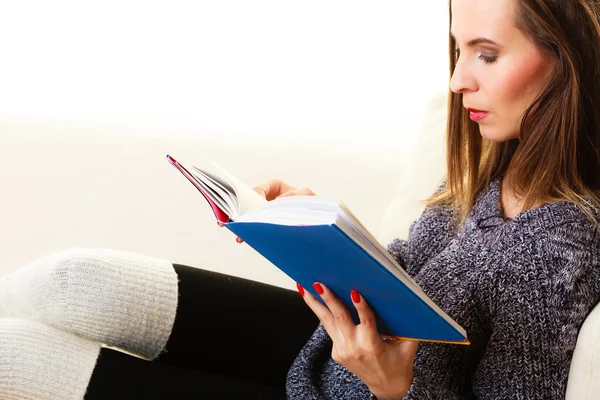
[167,156,469,344]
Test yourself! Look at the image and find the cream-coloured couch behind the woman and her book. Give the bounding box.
[0,93,600,400]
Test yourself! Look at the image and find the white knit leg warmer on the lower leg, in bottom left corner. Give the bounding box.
[0,318,100,400]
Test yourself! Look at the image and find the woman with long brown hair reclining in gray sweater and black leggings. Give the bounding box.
[0,0,600,400]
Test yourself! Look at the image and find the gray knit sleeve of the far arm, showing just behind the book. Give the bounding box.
[387,203,456,276]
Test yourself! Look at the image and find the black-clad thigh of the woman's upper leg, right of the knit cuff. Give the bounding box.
[156,264,319,389]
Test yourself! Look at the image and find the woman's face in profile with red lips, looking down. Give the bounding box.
[450,0,555,142]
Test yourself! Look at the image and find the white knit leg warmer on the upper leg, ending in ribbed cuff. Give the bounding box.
[0,249,178,359]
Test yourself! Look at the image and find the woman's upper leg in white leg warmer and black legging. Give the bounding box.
[0,249,318,396]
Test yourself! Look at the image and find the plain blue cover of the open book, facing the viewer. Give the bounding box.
[225,222,467,343]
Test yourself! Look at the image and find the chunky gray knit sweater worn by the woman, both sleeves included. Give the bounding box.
[287,181,600,400]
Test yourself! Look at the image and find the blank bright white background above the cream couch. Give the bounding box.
[0,0,448,151]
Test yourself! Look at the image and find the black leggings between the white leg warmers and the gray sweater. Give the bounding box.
[85,264,318,400]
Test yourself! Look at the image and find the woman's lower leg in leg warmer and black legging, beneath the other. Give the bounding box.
[0,318,285,400]
